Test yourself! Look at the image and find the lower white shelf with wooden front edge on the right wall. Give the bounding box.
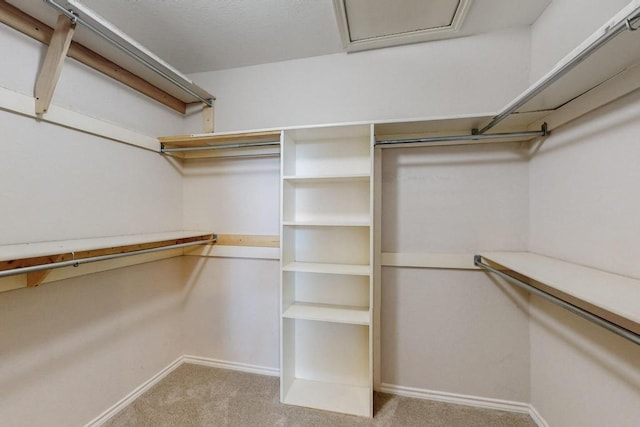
[481,252,640,334]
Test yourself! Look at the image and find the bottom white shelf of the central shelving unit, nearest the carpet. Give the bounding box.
[283,379,373,417]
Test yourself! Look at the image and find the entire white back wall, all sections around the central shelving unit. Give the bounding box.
[184,30,529,401]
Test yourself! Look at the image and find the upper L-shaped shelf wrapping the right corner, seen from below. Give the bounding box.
[375,0,640,146]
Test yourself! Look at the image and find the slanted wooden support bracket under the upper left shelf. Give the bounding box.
[35,15,76,115]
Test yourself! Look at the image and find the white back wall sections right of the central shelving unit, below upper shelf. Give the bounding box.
[381,144,529,402]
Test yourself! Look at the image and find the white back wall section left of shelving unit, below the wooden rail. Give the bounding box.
[184,256,280,371]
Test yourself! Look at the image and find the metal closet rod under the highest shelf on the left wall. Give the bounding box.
[44,0,215,107]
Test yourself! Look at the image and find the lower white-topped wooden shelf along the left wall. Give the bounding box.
[0,231,213,286]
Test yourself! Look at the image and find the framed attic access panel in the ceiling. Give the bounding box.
[333,0,472,52]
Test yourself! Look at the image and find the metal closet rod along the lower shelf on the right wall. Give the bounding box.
[473,255,640,345]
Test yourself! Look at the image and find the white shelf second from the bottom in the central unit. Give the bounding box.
[282,303,371,325]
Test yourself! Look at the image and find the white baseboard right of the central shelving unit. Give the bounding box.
[380,383,549,427]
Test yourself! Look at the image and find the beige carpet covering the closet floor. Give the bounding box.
[105,364,535,427]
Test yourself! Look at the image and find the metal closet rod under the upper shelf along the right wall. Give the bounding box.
[478,10,640,134]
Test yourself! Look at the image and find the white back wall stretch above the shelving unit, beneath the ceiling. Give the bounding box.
[187,29,530,132]
